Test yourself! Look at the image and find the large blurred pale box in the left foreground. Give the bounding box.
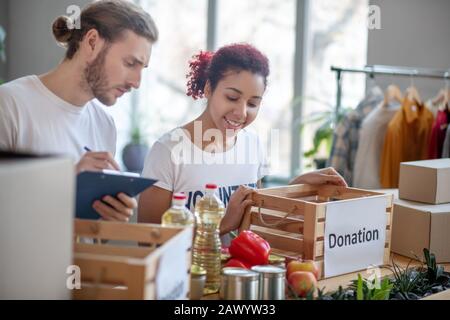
[0,155,75,299]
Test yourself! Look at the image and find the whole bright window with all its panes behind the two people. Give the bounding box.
[113,0,368,178]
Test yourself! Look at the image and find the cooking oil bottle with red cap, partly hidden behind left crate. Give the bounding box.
[161,193,194,227]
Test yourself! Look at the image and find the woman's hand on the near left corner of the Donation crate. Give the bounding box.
[220,186,253,235]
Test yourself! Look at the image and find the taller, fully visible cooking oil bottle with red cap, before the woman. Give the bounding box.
[192,184,224,294]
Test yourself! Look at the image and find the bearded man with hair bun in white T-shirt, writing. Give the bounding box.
[0,1,158,221]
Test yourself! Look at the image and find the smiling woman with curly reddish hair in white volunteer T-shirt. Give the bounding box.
[138,44,346,235]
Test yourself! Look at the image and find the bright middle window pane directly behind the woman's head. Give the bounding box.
[217,0,295,176]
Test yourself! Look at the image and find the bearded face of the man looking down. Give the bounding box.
[84,31,152,106]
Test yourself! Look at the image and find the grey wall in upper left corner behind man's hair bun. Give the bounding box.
[6,0,90,80]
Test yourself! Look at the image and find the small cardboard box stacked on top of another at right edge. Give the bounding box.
[399,159,450,204]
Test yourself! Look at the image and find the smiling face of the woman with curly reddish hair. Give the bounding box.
[205,71,265,135]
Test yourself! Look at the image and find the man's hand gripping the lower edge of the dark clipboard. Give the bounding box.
[92,193,137,222]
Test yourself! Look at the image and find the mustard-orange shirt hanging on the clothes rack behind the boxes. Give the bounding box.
[380,98,434,188]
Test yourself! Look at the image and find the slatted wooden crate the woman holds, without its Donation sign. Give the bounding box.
[239,185,393,277]
